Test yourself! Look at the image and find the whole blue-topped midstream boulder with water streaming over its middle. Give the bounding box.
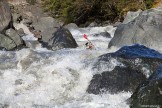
[87,44,162,94]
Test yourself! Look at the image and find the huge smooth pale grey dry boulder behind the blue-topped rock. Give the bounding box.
[108,9,162,49]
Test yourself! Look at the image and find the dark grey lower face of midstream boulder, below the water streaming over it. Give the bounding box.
[87,66,146,94]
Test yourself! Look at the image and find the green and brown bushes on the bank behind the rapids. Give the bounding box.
[42,0,154,25]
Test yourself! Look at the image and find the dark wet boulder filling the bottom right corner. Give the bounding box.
[130,64,162,108]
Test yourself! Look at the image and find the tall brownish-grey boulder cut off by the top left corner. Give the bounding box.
[0,0,11,32]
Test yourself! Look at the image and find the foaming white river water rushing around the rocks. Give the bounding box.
[0,26,131,108]
